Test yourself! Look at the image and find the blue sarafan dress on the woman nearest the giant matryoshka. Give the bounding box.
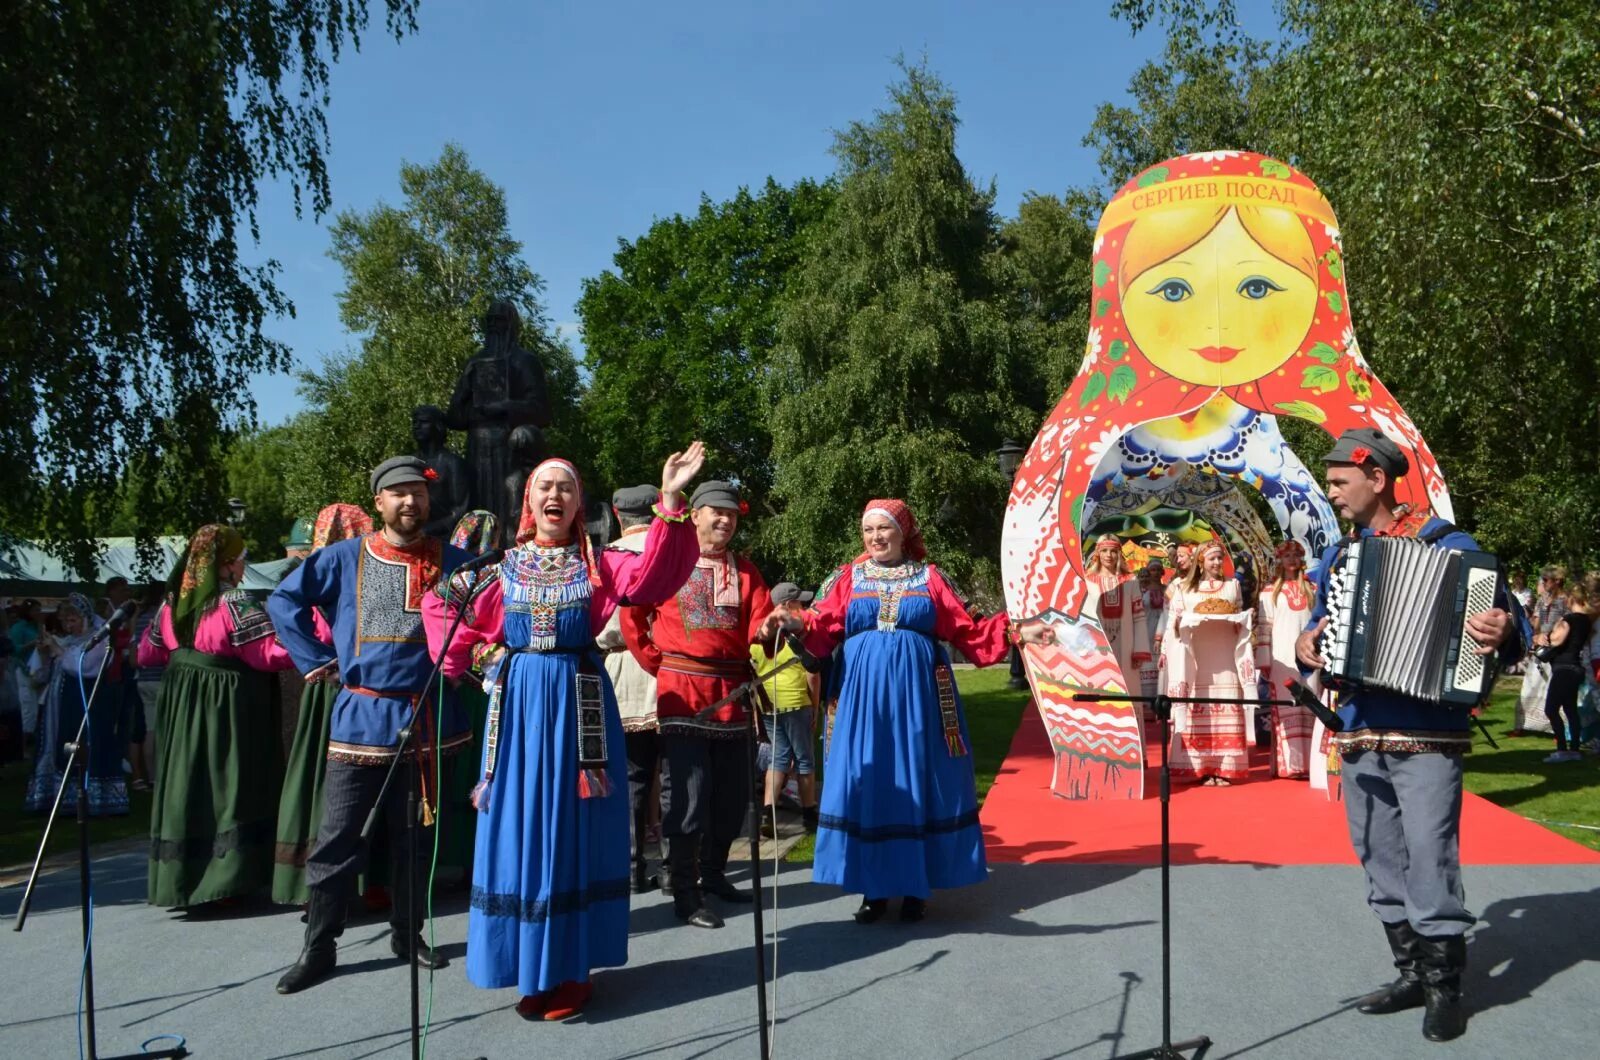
[813,564,989,898]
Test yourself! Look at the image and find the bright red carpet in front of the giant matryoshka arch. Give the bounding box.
[981,708,1600,865]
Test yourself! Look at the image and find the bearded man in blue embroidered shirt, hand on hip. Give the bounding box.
[267,456,470,994]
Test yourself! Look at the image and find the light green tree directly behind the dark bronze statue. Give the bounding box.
[285,144,581,514]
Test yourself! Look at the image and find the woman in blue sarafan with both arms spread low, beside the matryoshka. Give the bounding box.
[763,500,1054,924]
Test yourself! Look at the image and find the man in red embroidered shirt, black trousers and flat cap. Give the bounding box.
[622,482,773,927]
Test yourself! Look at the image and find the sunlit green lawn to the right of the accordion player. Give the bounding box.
[1466,677,1600,850]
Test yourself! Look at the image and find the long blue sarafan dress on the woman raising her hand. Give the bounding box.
[467,549,630,996]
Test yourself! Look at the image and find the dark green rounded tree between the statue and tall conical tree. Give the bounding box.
[578,179,832,519]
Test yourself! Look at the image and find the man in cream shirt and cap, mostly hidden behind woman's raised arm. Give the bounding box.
[595,485,661,893]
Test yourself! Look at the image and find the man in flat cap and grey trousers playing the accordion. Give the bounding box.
[1296,428,1530,1041]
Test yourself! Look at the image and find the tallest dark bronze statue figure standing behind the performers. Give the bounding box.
[445,301,550,538]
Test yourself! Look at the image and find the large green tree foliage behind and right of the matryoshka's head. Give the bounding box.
[1086,0,1600,567]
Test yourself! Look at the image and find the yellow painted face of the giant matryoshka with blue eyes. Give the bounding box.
[1122,207,1317,386]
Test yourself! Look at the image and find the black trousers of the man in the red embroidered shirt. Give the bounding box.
[661,733,750,873]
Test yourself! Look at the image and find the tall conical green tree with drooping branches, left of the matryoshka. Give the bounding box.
[762,64,1042,598]
